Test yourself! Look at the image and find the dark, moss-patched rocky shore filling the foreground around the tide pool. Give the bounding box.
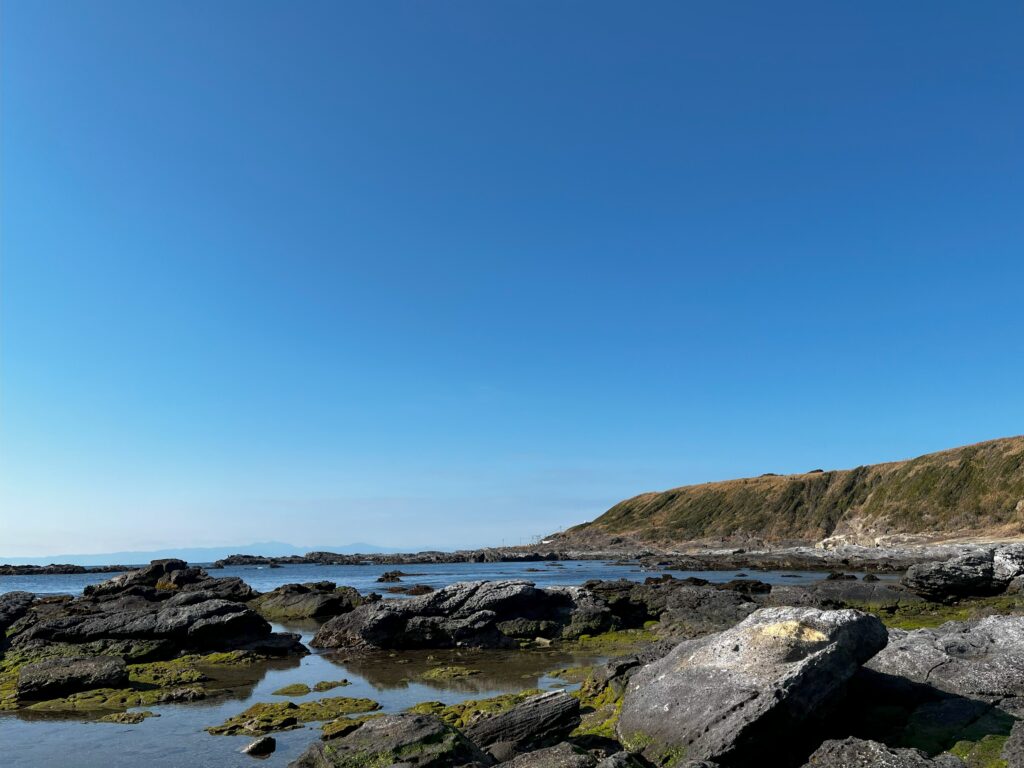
[6,545,1024,768]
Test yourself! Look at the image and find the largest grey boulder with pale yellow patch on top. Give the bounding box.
[616,607,887,766]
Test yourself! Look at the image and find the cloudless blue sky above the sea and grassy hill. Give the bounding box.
[0,0,1024,556]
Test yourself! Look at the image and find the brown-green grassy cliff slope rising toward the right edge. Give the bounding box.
[563,436,1024,545]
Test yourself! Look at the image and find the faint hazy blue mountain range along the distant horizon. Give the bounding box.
[0,542,406,565]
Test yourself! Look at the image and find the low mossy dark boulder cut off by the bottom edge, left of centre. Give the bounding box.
[289,715,493,768]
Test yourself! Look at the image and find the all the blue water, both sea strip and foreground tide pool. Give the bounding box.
[0,560,880,768]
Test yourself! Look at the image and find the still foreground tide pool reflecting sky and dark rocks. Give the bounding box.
[0,624,597,768]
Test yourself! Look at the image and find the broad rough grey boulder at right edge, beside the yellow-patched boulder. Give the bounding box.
[867,616,1024,709]
